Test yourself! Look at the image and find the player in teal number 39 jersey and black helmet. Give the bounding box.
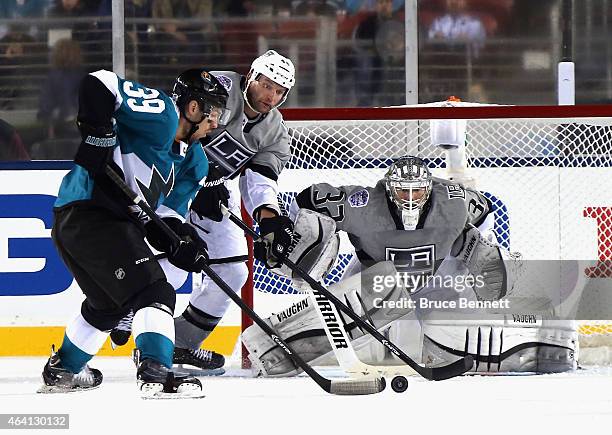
[41,69,228,397]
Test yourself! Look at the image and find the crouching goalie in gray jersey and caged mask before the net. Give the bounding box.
[243,156,573,375]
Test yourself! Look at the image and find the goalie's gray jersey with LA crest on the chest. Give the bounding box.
[296,179,490,274]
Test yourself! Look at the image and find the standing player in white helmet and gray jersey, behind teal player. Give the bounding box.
[113,50,295,370]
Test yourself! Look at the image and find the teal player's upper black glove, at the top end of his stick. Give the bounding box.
[74,122,117,177]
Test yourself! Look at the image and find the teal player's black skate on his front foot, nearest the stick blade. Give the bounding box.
[136,352,204,399]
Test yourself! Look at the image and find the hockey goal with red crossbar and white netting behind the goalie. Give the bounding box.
[243,101,612,368]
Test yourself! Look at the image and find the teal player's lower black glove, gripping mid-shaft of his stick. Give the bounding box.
[145,217,208,272]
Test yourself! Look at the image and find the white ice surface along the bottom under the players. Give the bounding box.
[0,357,612,435]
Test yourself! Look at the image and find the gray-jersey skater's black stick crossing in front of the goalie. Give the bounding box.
[221,205,474,381]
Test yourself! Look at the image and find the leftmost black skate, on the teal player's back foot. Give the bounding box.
[38,346,102,393]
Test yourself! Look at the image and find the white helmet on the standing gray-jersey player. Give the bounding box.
[243,50,295,107]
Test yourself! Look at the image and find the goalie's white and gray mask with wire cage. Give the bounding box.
[384,156,433,229]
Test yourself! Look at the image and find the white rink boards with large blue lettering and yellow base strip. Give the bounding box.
[0,162,612,355]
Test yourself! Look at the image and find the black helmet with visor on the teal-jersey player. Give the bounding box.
[172,68,229,114]
